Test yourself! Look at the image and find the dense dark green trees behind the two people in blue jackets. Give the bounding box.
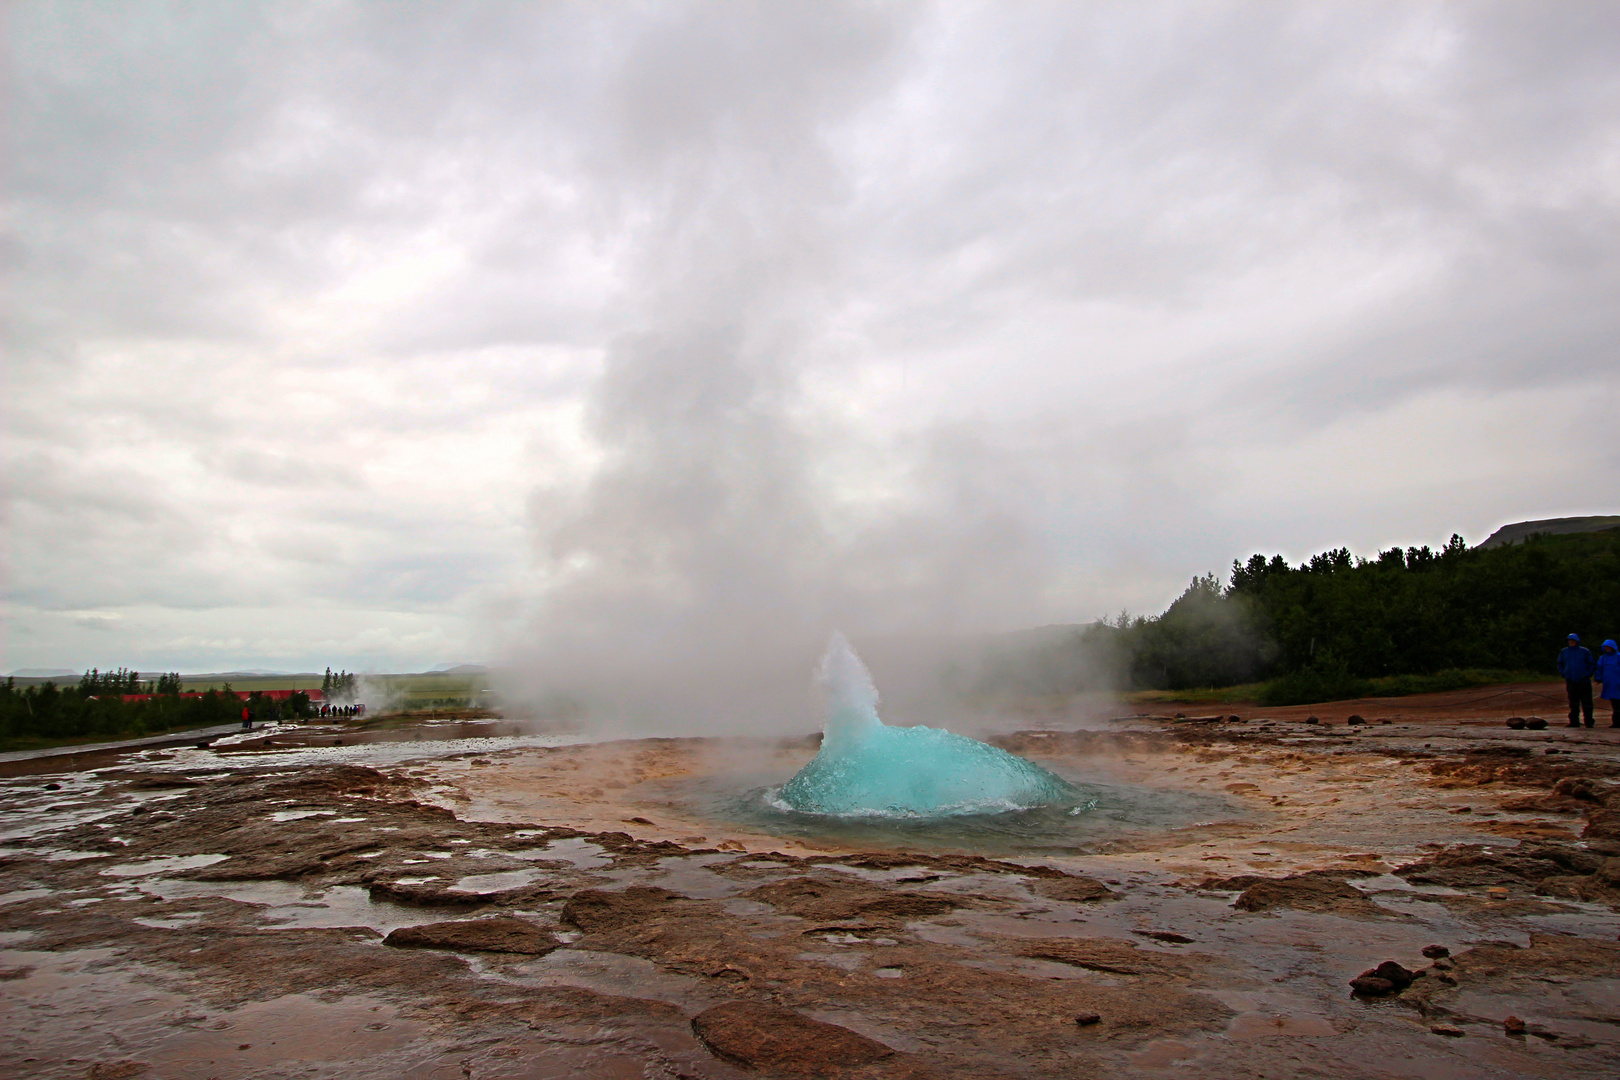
[965,529,1620,704]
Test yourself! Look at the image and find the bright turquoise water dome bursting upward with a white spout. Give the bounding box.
[781,633,1077,818]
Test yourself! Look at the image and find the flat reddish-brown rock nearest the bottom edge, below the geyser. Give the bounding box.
[692,1001,894,1078]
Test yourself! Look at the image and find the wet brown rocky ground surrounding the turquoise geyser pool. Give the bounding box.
[0,696,1620,1080]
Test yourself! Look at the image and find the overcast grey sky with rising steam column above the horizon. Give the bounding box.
[0,0,1620,670]
